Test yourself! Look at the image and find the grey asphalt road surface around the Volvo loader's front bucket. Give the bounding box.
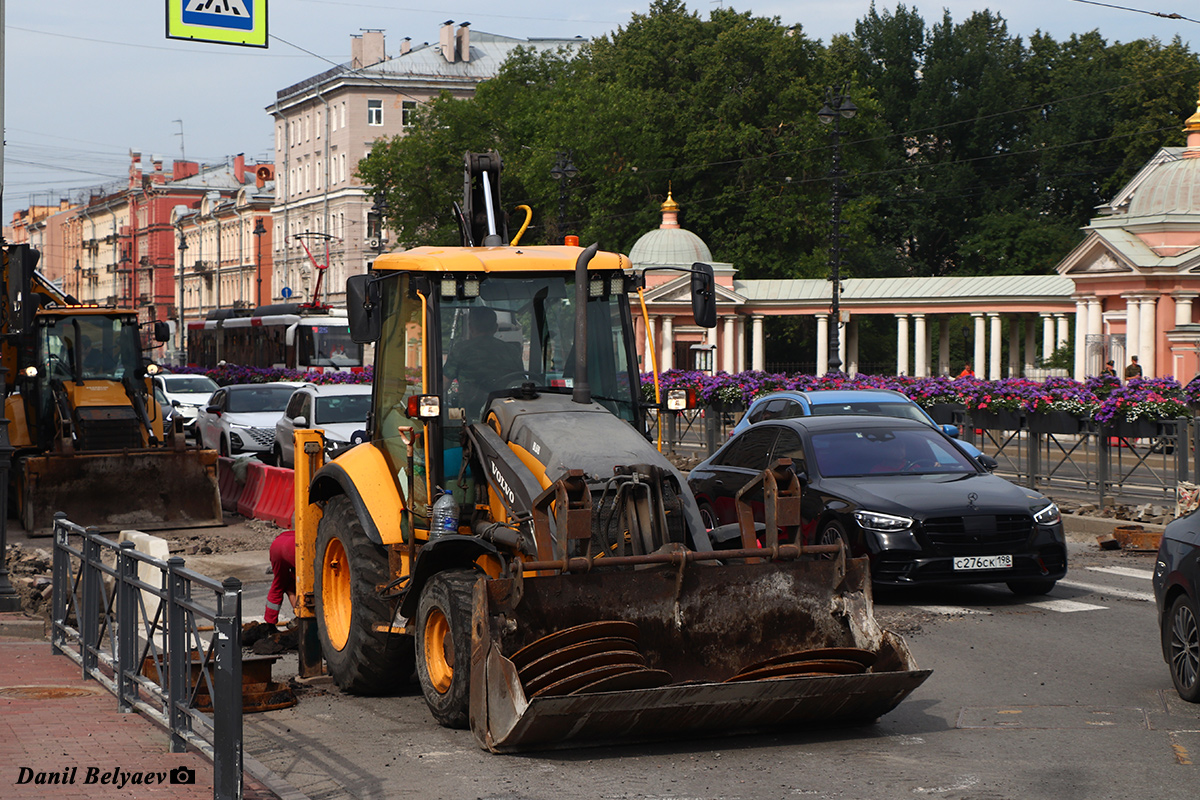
[236,543,1200,800]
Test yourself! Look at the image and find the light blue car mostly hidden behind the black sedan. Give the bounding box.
[730,389,992,460]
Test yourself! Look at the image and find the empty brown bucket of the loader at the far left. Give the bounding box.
[17,449,224,536]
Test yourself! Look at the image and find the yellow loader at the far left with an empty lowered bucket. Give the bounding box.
[0,245,222,535]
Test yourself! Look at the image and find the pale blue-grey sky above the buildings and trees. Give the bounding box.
[0,0,1200,215]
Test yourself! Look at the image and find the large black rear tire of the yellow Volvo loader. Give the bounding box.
[313,495,415,694]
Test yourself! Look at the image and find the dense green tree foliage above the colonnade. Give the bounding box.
[358,0,1200,278]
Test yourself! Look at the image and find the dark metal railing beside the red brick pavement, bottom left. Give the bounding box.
[50,513,242,800]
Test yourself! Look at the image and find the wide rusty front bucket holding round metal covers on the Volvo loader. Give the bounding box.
[470,558,930,752]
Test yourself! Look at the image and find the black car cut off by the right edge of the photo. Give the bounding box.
[1154,511,1200,703]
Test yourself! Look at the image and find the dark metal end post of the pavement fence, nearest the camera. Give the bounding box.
[212,578,242,800]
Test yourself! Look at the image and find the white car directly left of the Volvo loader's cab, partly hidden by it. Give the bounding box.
[272,384,371,467]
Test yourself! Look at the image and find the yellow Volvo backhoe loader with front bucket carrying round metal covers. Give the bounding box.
[288,152,929,752]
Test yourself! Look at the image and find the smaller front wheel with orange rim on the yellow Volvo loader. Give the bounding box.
[416,570,480,728]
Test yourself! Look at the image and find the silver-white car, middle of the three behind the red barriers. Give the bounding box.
[196,381,300,463]
